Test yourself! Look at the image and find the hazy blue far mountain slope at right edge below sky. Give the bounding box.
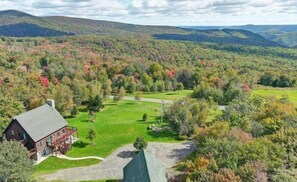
[183,25,297,47]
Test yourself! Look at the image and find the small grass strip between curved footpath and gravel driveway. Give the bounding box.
[36,157,101,175]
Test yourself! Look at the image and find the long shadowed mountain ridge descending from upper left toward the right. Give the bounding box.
[0,10,280,46]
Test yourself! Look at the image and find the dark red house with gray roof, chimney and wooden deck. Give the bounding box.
[3,100,77,163]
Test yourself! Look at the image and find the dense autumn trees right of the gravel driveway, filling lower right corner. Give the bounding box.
[166,96,297,182]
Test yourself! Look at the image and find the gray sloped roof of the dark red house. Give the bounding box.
[15,104,68,142]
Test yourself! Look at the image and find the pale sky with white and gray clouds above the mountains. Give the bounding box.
[0,0,297,26]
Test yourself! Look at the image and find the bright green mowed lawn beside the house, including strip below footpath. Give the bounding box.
[36,101,178,175]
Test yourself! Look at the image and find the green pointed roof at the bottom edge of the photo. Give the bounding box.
[124,149,167,182]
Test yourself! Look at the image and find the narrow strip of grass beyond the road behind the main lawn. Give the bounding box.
[130,90,193,100]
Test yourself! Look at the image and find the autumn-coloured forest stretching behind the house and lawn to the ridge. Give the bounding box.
[0,36,297,133]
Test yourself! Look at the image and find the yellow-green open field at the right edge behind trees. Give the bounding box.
[252,88,297,105]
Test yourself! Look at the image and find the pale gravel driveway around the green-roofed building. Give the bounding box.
[42,142,195,181]
